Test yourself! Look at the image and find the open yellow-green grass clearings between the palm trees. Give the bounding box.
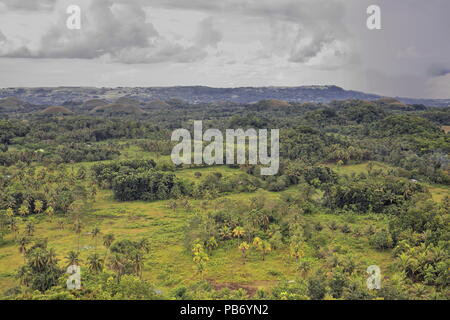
[0,158,442,293]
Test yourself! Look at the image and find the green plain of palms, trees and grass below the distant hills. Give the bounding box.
[0,98,450,300]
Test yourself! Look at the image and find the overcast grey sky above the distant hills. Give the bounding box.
[0,0,450,98]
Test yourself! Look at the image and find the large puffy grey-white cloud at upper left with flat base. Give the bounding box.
[0,0,214,64]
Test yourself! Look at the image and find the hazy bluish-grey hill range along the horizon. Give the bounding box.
[0,86,450,107]
